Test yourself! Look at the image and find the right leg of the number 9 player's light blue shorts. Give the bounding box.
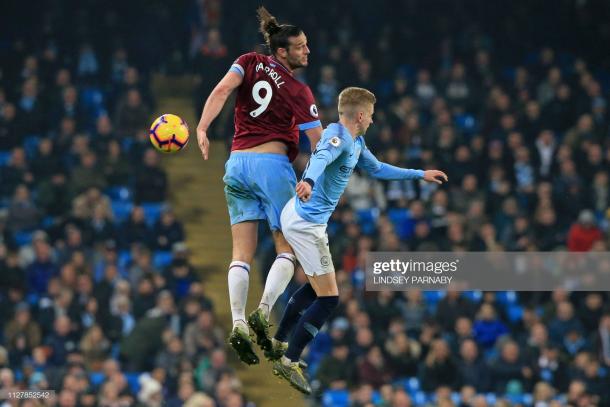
[257,159,296,231]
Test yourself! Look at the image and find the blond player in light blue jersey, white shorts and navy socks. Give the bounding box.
[272,87,447,394]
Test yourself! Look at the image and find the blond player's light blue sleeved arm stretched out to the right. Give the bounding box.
[357,148,448,184]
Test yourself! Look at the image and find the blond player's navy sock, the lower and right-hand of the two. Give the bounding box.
[286,295,339,362]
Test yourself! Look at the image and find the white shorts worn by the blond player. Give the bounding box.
[280,197,335,276]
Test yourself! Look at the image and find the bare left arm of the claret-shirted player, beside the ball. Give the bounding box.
[197,71,243,160]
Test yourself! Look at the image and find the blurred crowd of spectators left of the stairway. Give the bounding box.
[0,2,247,407]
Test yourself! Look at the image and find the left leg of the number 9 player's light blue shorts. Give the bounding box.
[223,156,266,225]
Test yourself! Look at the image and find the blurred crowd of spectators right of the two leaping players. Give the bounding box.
[205,0,610,407]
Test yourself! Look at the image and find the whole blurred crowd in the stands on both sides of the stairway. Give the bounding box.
[0,0,610,407]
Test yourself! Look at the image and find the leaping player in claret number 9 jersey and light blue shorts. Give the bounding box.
[197,7,322,364]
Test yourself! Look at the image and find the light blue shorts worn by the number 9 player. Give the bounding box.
[223,152,297,230]
